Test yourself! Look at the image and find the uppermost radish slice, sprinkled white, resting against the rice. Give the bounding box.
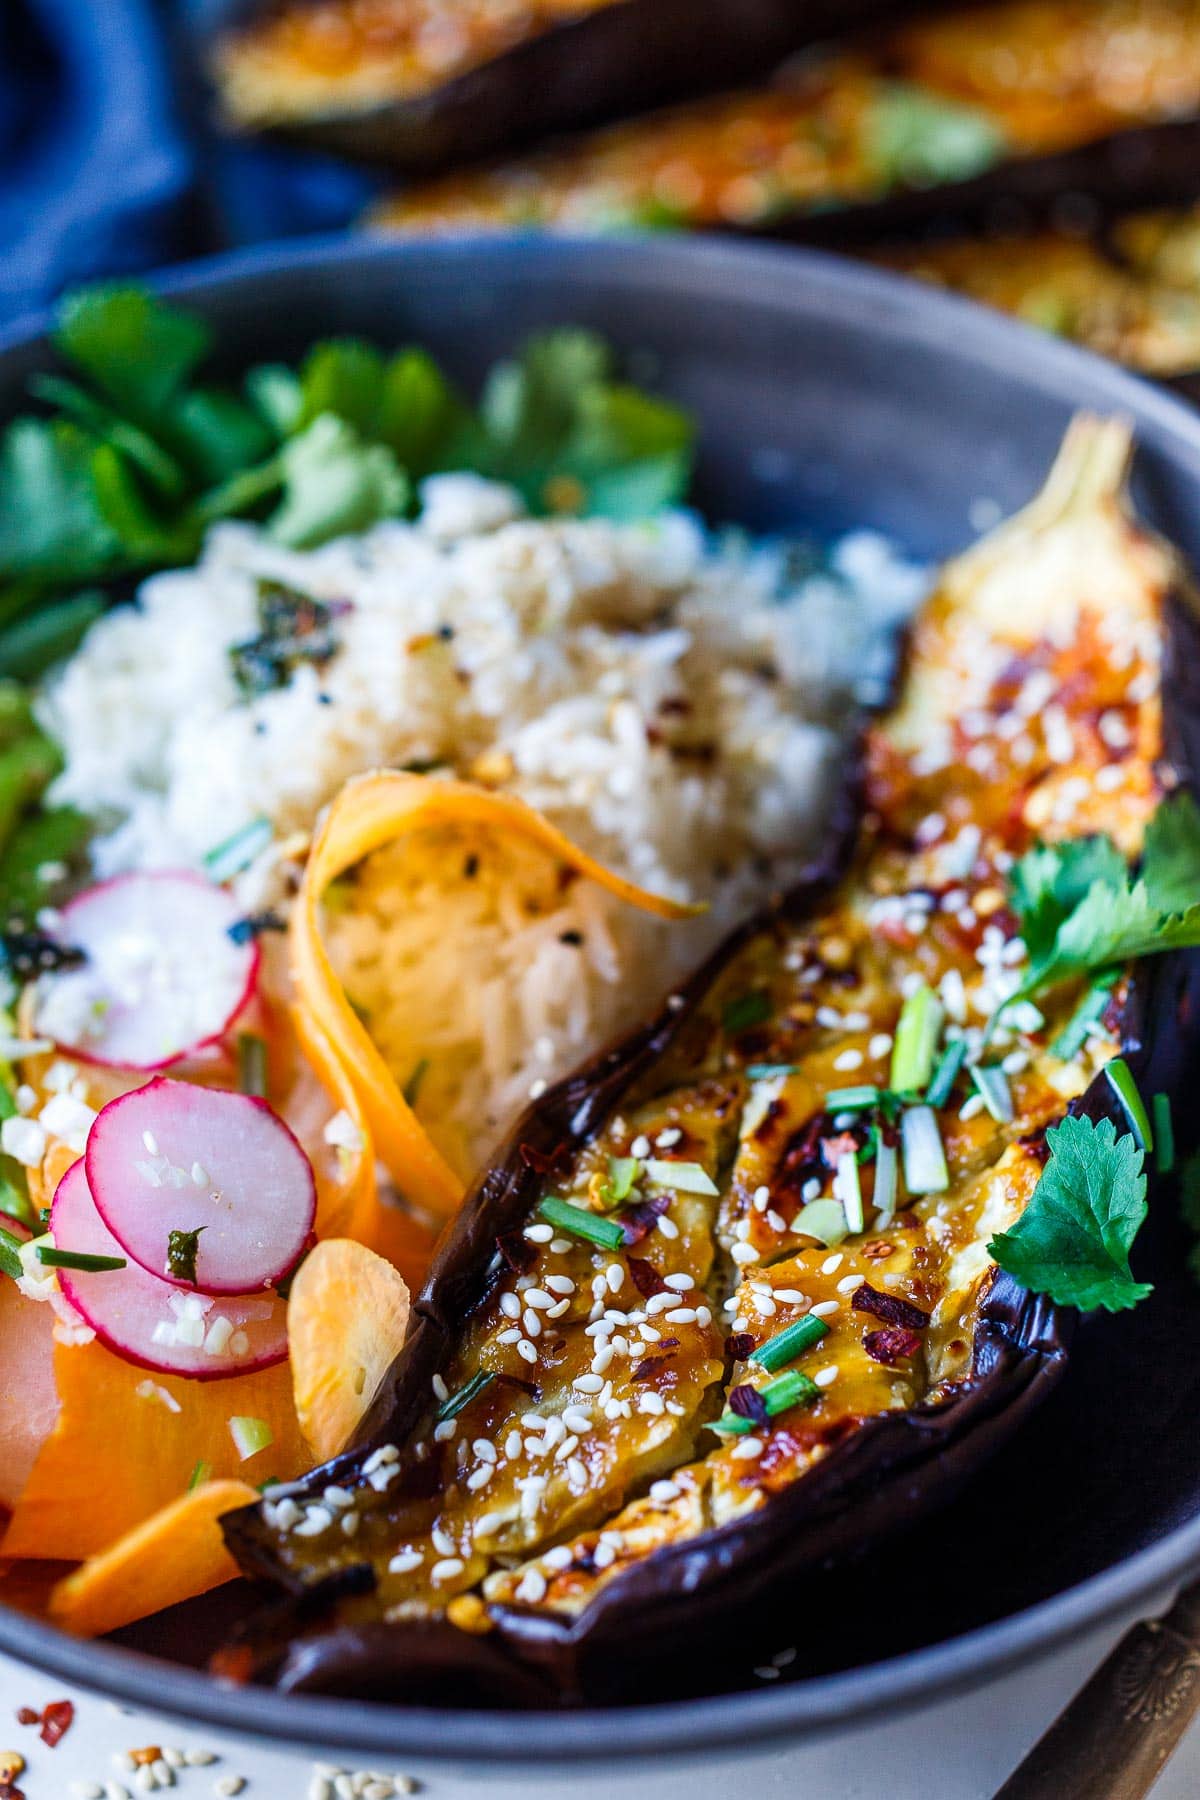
[36,869,259,1069]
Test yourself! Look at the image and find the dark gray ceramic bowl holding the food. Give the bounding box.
[0,239,1200,1768]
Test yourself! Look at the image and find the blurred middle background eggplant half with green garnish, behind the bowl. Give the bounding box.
[374,0,1200,243]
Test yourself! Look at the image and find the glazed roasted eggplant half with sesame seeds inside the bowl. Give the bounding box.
[219,419,1200,1701]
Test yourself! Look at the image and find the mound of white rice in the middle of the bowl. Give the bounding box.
[35,475,923,1172]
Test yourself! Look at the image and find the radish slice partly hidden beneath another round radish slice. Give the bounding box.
[50,1163,288,1381]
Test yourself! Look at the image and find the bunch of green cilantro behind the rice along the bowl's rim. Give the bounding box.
[0,286,693,640]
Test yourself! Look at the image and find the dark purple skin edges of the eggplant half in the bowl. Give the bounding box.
[219,446,1200,1706]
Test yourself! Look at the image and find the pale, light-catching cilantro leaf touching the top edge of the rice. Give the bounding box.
[268,412,408,549]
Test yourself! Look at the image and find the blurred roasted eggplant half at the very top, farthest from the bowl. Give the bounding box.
[210,0,910,171]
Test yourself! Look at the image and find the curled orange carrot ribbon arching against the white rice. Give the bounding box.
[290,770,703,1217]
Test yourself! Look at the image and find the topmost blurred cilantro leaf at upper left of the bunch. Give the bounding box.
[54,286,210,421]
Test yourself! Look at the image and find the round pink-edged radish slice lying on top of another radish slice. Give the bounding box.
[86,1075,317,1294]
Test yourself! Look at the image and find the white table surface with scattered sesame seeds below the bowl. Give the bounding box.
[0,1633,1200,1800]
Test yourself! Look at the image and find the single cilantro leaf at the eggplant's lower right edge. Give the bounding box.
[988,1116,1151,1312]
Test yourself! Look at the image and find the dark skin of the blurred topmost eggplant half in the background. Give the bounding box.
[210,0,909,175]
